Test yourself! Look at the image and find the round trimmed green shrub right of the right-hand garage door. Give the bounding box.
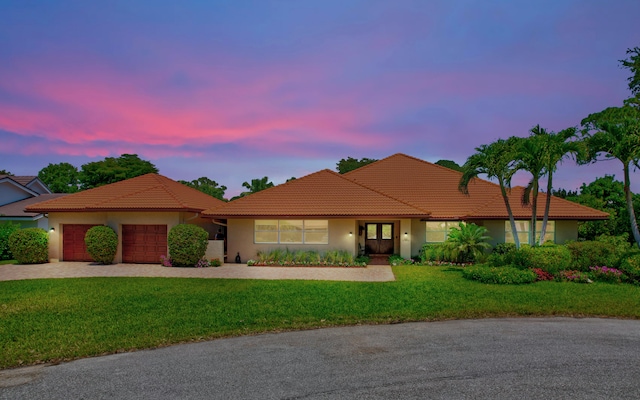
[168,224,209,267]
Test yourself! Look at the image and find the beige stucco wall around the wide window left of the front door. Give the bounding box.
[227,219,358,263]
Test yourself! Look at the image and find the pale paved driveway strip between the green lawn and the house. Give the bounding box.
[0,262,395,282]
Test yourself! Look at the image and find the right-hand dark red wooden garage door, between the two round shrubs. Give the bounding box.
[122,225,167,264]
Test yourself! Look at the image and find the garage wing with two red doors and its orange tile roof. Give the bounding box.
[26,174,225,264]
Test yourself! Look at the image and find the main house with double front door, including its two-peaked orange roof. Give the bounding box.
[202,154,608,260]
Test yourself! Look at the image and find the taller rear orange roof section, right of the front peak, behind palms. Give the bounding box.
[344,154,608,220]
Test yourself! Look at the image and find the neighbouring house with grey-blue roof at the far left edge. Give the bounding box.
[0,175,65,229]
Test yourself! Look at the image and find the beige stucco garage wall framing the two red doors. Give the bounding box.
[49,211,215,263]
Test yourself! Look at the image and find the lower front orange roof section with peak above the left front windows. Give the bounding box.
[204,169,429,218]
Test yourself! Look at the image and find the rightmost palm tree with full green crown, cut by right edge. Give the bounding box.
[581,102,640,246]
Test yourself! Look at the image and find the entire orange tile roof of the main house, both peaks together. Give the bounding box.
[204,154,608,220]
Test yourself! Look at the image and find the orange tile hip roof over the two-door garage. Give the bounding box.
[27,174,225,212]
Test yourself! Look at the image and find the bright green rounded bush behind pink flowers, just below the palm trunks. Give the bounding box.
[513,245,571,275]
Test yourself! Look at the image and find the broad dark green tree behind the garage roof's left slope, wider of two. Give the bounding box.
[79,154,158,190]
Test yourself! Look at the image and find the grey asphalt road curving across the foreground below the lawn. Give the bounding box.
[0,318,640,400]
